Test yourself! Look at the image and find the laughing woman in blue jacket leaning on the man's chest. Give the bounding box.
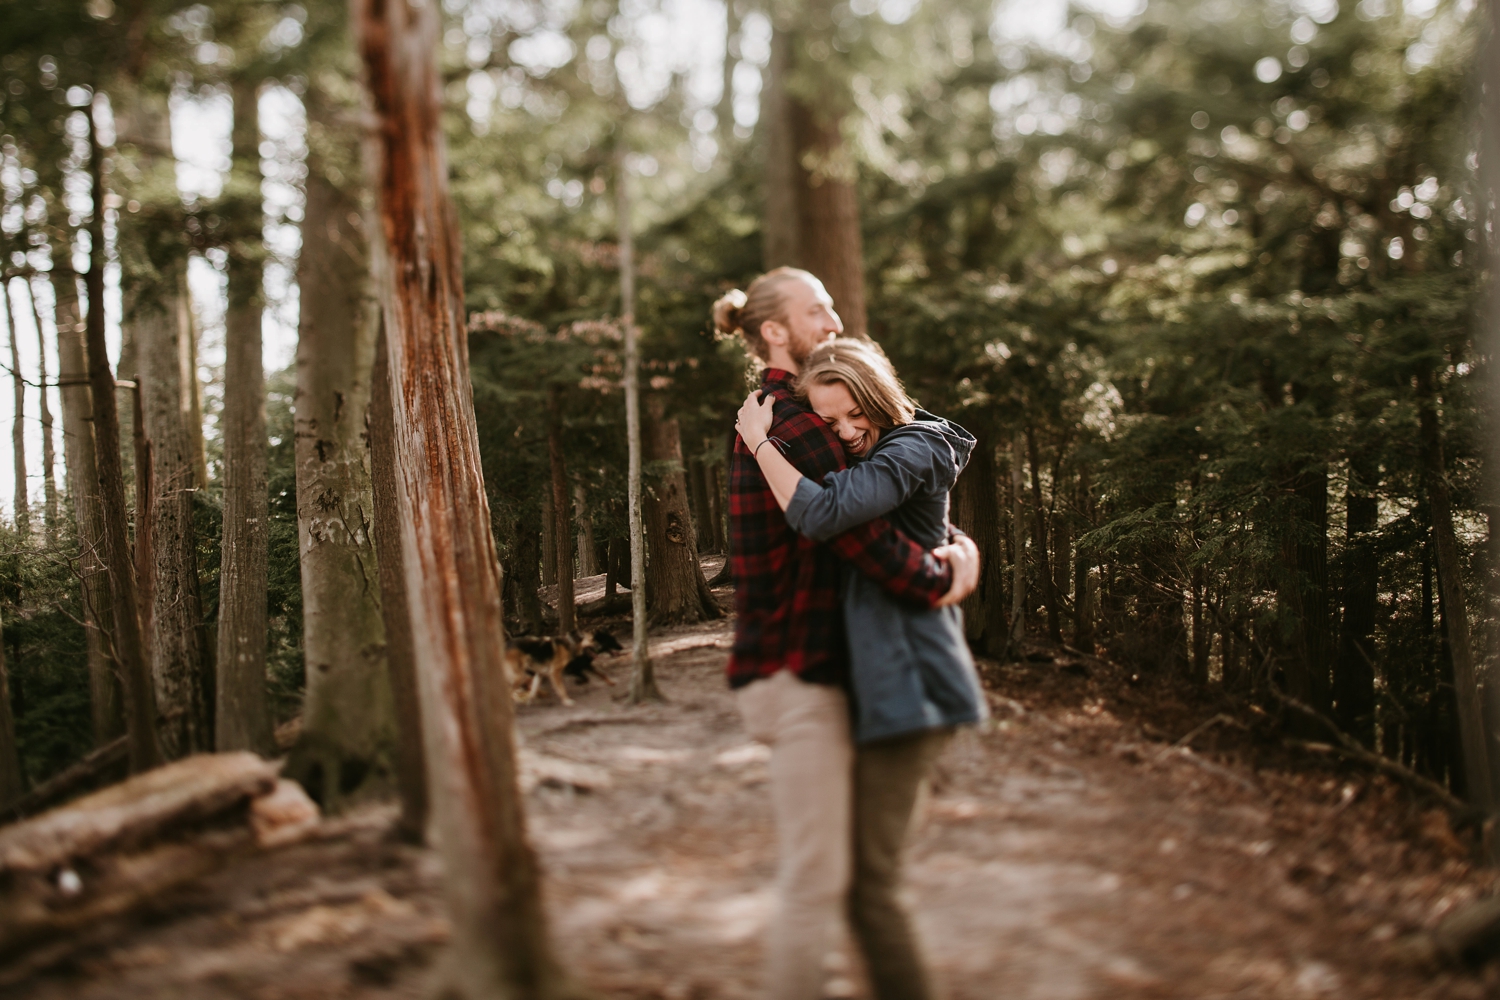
[737,339,986,1000]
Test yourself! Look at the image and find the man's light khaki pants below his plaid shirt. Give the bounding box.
[737,670,854,1000]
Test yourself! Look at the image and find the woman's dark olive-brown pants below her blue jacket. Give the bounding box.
[849,729,953,1000]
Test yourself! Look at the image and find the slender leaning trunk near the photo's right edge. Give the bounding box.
[1418,370,1496,810]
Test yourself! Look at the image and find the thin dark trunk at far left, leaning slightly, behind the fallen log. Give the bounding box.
[84,99,162,774]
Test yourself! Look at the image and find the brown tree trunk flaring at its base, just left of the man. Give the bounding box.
[641,394,723,624]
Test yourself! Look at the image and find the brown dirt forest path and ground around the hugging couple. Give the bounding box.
[8,602,1500,1000]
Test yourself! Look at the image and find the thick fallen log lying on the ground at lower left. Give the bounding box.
[0,753,318,961]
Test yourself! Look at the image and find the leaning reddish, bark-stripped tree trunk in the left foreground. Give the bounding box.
[354,0,572,1000]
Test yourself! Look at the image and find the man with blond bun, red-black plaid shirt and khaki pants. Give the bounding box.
[714,268,978,1000]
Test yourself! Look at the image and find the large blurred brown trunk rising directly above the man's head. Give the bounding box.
[762,7,869,337]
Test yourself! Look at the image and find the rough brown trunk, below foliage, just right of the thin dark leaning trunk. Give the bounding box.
[131,274,210,760]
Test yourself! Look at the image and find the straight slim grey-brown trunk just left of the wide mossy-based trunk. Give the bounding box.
[217,76,273,755]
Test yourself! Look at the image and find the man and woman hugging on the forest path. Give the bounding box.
[714,267,986,1000]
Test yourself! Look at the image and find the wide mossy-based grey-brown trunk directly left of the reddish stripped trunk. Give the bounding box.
[288,94,396,791]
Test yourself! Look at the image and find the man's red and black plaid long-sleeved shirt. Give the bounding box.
[729,369,953,688]
